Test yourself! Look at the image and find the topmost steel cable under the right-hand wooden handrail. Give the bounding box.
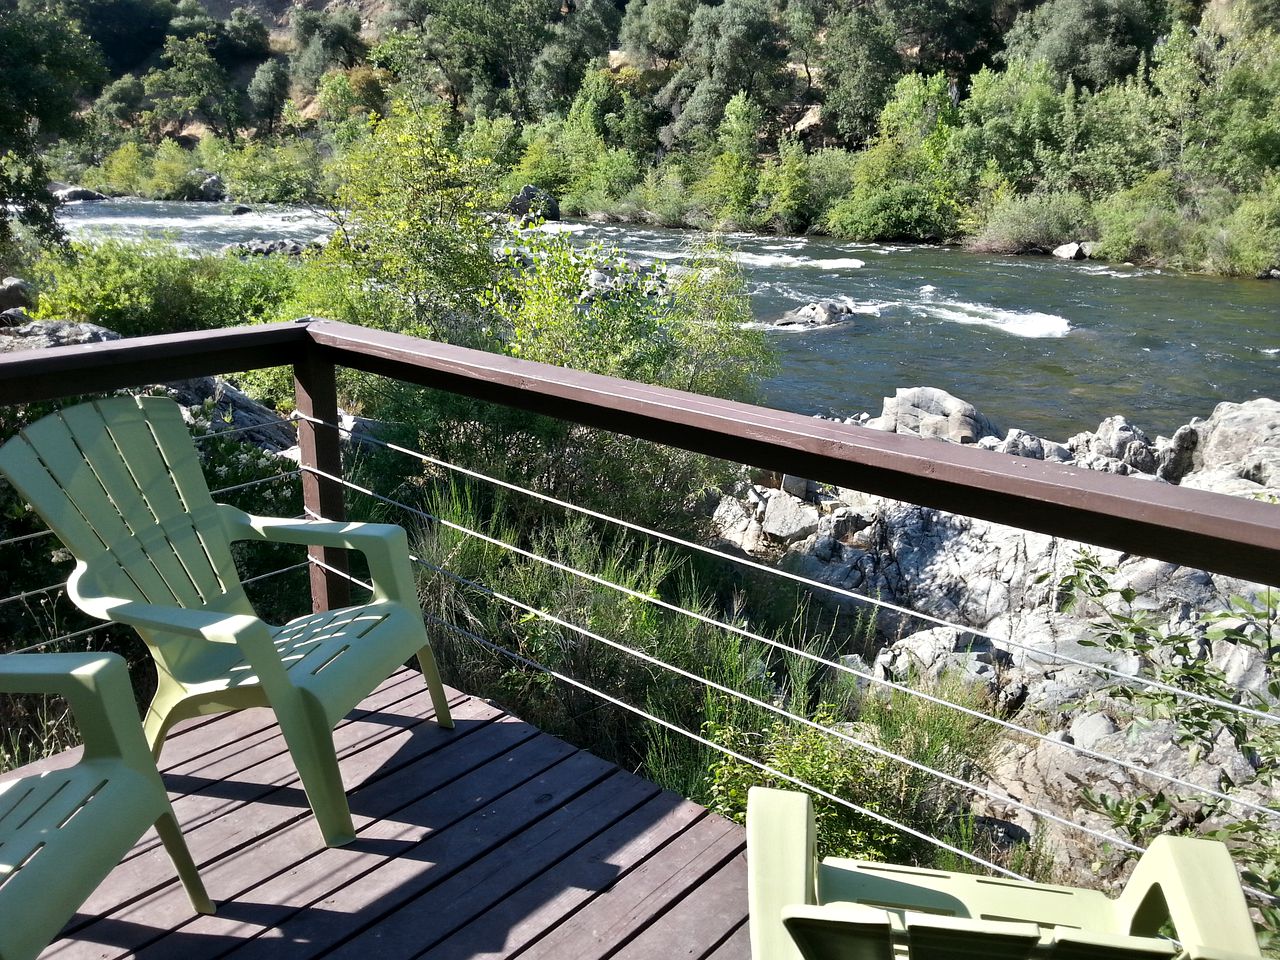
[298,415,1280,727]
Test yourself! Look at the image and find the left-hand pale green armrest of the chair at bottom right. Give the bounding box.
[746,787,818,960]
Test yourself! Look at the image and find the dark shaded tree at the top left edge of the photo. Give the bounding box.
[0,0,102,255]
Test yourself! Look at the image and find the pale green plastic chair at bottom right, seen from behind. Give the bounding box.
[746,787,1262,960]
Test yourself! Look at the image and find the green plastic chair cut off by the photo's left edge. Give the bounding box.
[0,653,214,960]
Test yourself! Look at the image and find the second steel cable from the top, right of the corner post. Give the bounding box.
[306,467,1280,842]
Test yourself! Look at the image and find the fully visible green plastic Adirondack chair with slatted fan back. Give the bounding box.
[0,397,453,846]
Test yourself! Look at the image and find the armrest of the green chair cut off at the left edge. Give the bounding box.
[0,653,155,776]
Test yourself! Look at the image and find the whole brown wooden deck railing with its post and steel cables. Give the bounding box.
[0,319,1280,873]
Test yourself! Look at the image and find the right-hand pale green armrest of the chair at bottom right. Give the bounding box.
[1116,836,1262,957]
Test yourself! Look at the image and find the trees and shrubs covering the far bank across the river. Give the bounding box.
[0,0,1280,275]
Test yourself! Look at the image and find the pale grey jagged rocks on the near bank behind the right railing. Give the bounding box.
[713,388,1280,882]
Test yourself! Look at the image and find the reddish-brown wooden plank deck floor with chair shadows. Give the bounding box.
[24,671,749,960]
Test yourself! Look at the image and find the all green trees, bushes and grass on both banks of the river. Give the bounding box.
[0,0,1277,947]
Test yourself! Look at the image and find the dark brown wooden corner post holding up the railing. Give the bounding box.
[293,347,351,613]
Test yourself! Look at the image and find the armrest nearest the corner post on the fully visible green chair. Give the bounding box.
[219,504,419,608]
